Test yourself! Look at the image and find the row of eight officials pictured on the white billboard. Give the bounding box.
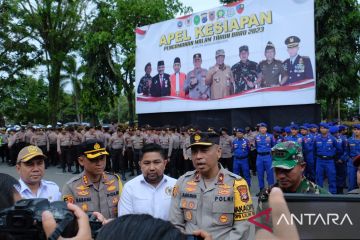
[137,36,314,100]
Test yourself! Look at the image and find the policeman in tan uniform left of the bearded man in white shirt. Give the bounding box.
[62,140,122,218]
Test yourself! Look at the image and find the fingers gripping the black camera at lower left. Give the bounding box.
[41,203,91,240]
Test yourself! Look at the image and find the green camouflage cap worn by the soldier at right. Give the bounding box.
[271,141,305,169]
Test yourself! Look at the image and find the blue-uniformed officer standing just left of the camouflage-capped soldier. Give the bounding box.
[255,123,275,196]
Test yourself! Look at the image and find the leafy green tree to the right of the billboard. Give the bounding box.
[315,0,360,119]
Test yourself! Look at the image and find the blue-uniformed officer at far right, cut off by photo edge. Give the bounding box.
[346,124,360,191]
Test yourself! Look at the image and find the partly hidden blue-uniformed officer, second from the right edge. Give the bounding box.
[329,126,347,194]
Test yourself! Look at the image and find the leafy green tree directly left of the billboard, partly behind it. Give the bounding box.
[82,0,190,124]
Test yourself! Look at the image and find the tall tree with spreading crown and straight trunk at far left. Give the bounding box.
[7,0,87,124]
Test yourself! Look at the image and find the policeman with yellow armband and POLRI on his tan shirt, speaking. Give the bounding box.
[170,133,254,240]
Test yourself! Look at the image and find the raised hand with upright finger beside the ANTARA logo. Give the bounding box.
[255,187,300,240]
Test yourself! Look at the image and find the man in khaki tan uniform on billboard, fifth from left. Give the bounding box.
[205,49,234,100]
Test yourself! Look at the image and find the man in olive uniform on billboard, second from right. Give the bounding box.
[257,41,287,87]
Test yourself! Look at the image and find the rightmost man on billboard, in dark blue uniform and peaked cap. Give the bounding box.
[283,36,314,85]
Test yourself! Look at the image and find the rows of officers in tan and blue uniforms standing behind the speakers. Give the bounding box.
[0,123,360,194]
